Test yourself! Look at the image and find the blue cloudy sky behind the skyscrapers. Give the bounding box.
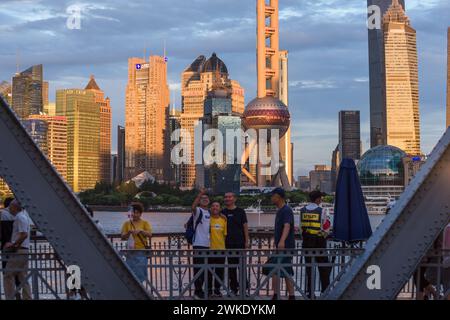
[0,0,450,176]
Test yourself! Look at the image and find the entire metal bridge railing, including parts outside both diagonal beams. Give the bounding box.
[0,233,450,300]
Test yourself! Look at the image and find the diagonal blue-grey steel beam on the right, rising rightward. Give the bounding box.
[326,128,450,300]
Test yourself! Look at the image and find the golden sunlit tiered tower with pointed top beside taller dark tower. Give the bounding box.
[383,0,421,155]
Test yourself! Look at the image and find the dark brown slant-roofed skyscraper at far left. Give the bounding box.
[12,64,44,119]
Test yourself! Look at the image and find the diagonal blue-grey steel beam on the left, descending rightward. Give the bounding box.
[0,97,150,300]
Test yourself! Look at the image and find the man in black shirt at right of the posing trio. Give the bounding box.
[222,192,250,295]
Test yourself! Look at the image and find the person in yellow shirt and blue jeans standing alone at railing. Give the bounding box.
[122,203,152,282]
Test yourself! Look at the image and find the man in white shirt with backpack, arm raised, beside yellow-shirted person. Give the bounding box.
[185,188,211,299]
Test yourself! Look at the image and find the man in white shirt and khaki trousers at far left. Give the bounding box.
[4,200,31,300]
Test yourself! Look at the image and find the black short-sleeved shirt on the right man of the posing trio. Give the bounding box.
[222,208,248,248]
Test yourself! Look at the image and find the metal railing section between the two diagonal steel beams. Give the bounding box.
[125,248,362,300]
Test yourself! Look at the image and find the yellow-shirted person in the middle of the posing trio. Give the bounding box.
[208,202,227,297]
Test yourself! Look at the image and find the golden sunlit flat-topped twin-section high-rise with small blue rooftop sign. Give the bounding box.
[125,56,170,182]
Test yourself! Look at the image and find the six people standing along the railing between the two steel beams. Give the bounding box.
[122,188,331,300]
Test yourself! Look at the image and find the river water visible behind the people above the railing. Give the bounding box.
[95,212,384,234]
